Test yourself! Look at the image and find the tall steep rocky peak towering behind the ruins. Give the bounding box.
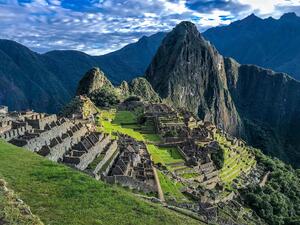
[146,22,242,135]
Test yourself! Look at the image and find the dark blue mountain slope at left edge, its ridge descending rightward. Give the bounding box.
[0,41,69,112]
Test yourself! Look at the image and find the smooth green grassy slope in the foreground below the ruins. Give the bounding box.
[0,141,199,225]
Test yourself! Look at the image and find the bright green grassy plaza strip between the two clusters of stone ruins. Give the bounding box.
[98,109,187,200]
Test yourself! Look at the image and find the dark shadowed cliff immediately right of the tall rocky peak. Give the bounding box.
[225,58,300,166]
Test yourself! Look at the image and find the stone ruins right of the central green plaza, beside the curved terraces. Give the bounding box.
[145,104,251,204]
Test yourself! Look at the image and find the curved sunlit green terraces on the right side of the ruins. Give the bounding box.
[216,134,256,184]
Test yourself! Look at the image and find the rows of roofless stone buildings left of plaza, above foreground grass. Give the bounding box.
[0,106,157,193]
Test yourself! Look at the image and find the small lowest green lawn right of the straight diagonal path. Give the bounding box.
[157,170,187,202]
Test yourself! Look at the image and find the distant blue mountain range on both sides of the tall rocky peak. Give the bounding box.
[0,13,300,112]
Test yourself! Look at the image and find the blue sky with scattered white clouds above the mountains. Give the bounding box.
[0,0,300,55]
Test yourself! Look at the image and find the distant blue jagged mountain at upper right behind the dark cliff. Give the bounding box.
[203,13,300,80]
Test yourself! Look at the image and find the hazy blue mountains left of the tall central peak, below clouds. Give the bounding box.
[0,33,165,112]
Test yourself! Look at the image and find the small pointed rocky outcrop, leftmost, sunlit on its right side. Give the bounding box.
[76,68,113,95]
